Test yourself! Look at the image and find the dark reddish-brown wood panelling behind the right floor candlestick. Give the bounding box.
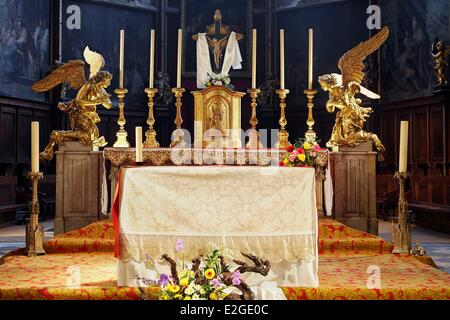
[377,93,450,232]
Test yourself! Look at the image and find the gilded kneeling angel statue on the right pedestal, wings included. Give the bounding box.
[319,27,389,160]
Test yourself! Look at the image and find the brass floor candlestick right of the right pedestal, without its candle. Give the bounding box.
[392,172,411,254]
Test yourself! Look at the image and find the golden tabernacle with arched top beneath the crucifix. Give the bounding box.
[192,86,245,148]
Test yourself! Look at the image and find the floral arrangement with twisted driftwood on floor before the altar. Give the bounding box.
[140,240,270,300]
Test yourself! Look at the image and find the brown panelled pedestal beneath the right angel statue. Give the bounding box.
[330,143,378,235]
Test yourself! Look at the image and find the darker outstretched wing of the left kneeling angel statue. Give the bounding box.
[31,60,86,92]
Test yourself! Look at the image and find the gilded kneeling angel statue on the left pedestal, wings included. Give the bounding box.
[32,47,112,160]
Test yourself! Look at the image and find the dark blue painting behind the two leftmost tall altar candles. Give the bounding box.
[61,0,156,110]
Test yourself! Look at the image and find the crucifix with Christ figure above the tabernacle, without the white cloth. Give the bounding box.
[192,9,244,74]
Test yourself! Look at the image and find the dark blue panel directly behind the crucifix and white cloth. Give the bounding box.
[181,0,253,77]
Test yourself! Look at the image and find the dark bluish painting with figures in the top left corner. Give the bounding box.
[0,0,50,101]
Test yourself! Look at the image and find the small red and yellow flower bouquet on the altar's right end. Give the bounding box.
[280,139,322,167]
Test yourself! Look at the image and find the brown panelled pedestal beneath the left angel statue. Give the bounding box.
[55,142,103,234]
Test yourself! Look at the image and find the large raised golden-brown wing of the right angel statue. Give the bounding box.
[339,27,389,86]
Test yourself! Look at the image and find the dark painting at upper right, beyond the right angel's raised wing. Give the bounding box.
[381,0,450,103]
